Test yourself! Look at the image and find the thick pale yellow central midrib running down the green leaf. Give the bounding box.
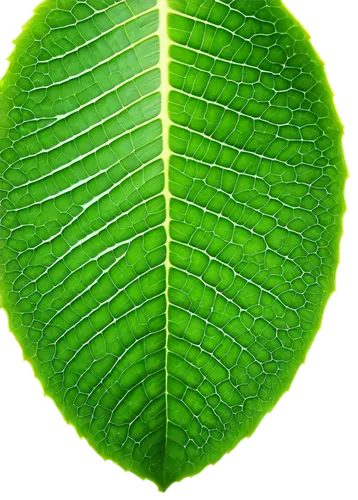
[157,0,170,466]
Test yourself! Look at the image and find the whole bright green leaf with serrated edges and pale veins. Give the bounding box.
[0,0,348,492]
